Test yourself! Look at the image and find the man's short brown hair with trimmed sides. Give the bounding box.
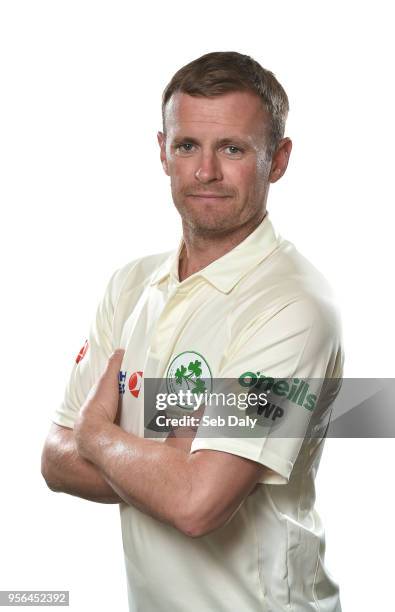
[162,51,289,157]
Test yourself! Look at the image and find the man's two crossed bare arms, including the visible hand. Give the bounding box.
[42,351,266,537]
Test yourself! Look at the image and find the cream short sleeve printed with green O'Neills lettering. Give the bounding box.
[191,299,343,484]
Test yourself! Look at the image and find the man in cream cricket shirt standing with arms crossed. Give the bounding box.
[42,52,343,612]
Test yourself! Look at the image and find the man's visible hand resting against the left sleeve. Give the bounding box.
[74,349,125,457]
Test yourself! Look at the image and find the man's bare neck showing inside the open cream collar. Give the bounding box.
[178,211,267,282]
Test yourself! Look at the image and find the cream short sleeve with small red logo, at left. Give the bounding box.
[52,270,119,428]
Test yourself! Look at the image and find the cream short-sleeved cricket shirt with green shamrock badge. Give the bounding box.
[53,215,343,612]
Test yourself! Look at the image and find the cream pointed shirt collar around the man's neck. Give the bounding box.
[150,212,281,293]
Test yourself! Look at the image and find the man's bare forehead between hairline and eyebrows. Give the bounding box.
[165,91,268,137]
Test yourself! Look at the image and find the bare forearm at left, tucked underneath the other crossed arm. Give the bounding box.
[41,430,123,504]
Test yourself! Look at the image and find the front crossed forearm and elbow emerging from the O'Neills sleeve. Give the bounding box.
[77,418,265,537]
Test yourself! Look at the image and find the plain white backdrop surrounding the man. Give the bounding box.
[0,0,395,612]
